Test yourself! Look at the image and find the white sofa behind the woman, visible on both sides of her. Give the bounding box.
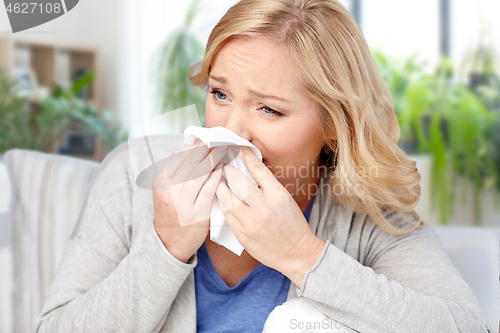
[0,149,500,333]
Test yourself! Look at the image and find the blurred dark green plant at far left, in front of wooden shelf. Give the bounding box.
[0,68,127,152]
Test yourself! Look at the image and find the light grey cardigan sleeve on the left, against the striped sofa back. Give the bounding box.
[36,146,197,333]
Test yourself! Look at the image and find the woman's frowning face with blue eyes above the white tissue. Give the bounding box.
[206,37,324,197]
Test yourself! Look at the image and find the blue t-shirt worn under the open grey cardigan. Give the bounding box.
[194,196,315,333]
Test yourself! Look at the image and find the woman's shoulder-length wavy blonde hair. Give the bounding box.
[189,0,422,234]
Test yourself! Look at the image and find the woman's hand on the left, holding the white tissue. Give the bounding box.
[153,139,227,263]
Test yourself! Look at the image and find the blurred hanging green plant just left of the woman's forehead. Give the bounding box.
[152,0,206,127]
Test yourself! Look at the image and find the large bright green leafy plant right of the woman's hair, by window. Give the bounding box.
[374,53,499,224]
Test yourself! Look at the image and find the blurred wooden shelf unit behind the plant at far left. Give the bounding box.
[0,35,104,162]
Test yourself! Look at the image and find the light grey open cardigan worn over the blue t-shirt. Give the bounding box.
[37,140,489,333]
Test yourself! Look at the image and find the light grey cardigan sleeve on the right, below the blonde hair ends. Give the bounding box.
[296,213,489,333]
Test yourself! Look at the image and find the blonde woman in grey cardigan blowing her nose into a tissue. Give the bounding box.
[38,0,488,333]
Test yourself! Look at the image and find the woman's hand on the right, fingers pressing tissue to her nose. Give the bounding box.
[216,147,325,288]
